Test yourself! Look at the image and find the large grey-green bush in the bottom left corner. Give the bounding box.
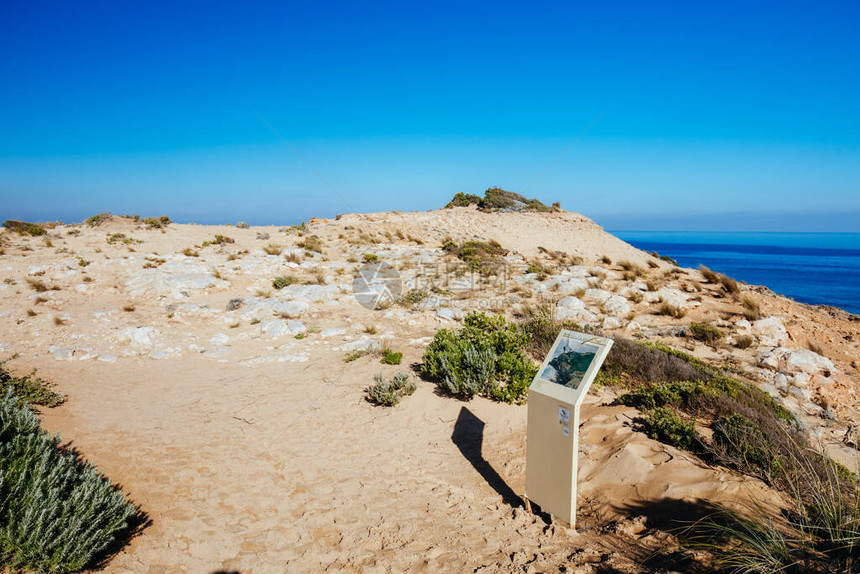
[0,392,136,572]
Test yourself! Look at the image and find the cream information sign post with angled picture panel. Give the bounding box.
[525,330,612,528]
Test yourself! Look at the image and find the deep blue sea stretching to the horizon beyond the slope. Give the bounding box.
[612,231,860,314]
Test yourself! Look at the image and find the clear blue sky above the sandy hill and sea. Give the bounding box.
[0,0,860,231]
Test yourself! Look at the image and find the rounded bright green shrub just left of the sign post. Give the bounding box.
[421,312,537,403]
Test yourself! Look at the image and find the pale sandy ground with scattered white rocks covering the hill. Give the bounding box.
[0,209,860,572]
